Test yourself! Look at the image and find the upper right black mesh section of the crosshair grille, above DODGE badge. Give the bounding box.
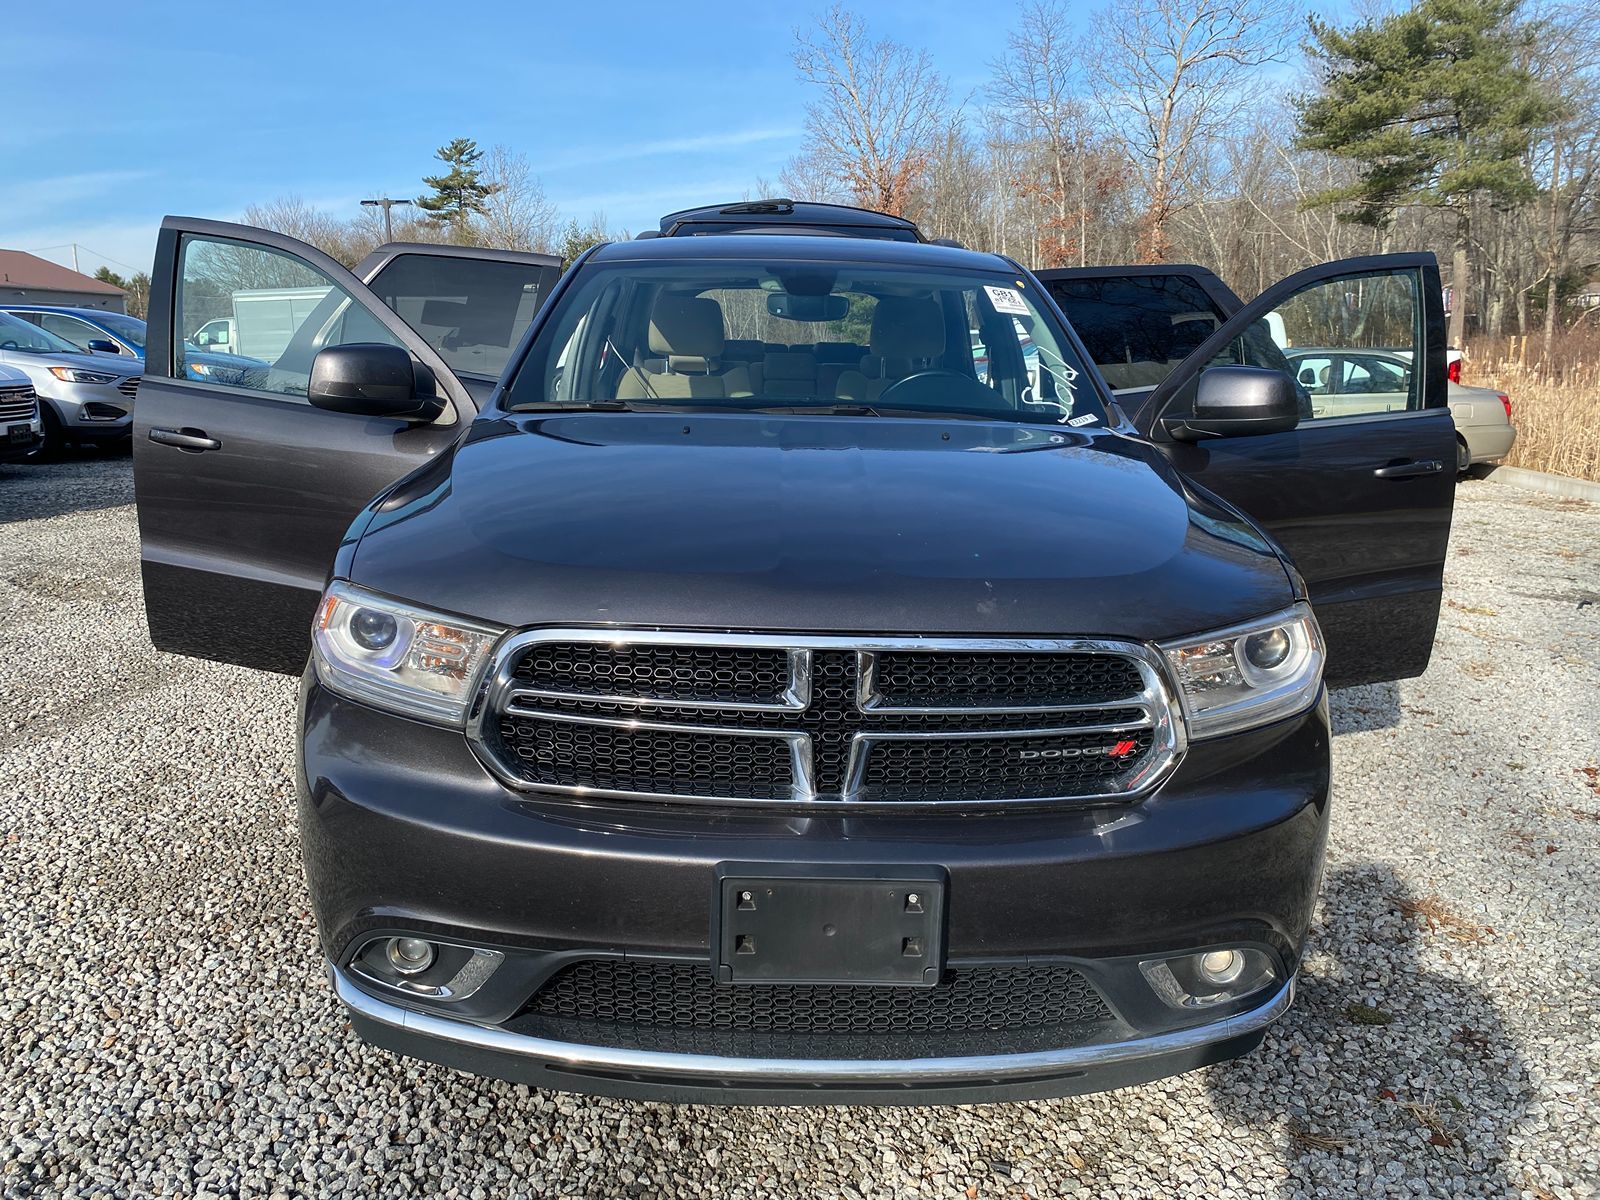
[875,651,1144,707]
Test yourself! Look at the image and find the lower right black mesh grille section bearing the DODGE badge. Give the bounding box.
[861,730,1152,800]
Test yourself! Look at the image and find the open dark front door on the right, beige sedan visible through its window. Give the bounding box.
[1138,254,1456,686]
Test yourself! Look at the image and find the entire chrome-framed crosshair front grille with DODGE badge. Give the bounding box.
[472,629,1182,810]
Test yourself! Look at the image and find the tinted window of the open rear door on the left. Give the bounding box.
[368,254,557,379]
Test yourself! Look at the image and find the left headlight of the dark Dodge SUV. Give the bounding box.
[312,582,506,725]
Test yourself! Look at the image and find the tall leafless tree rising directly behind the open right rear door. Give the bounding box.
[1093,0,1291,262]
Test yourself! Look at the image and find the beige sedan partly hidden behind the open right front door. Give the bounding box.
[1286,346,1517,470]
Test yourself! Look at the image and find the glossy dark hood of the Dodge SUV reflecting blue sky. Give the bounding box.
[353,413,1293,640]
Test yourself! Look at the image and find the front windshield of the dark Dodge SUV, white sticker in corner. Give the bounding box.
[507,259,1106,427]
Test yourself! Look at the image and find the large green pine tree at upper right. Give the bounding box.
[1298,0,1554,346]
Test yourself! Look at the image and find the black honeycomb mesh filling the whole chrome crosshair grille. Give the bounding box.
[486,642,1155,803]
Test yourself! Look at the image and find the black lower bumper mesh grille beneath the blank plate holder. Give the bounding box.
[526,958,1112,1035]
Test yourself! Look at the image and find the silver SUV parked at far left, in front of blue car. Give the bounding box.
[0,312,144,456]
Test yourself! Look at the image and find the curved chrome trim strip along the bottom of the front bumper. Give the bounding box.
[328,963,1294,1083]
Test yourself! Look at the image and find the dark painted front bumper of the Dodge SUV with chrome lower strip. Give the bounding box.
[299,677,1328,1104]
